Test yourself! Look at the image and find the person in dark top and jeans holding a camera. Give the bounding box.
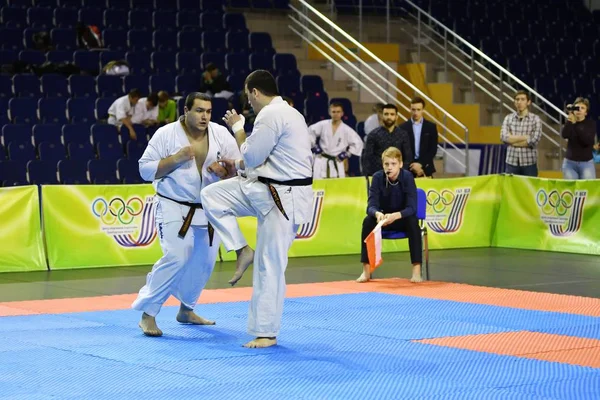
[561,97,596,179]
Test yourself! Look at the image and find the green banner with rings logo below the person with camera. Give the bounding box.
[492,176,600,254]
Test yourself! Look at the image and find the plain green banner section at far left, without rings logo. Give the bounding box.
[0,186,47,272]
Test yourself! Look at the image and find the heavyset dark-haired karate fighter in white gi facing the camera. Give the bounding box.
[132,93,240,336]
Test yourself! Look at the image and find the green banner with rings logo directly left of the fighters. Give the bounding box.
[42,185,162,269]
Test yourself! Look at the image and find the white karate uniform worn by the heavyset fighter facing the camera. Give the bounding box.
[132,102,240,336]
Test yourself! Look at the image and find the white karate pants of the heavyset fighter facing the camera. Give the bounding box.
[132,202,220,317]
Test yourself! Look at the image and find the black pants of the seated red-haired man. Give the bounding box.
[360,215,423,264]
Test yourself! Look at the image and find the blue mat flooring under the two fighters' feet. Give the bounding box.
[0,293,600,400]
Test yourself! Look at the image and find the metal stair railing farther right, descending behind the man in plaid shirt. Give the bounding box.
[329,0,567,161]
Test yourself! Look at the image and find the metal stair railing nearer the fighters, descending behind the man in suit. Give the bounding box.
[288,0,469,175]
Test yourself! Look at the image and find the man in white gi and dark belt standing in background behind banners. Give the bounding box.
[308,102,363,179]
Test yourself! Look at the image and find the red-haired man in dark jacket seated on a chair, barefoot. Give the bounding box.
[356,147,423,283]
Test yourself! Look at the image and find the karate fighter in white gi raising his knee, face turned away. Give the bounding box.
[201,70,313,347]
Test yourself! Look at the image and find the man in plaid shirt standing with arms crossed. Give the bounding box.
[500,90,542,176]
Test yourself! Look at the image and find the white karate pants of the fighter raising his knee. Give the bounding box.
[201,177,298,337]
